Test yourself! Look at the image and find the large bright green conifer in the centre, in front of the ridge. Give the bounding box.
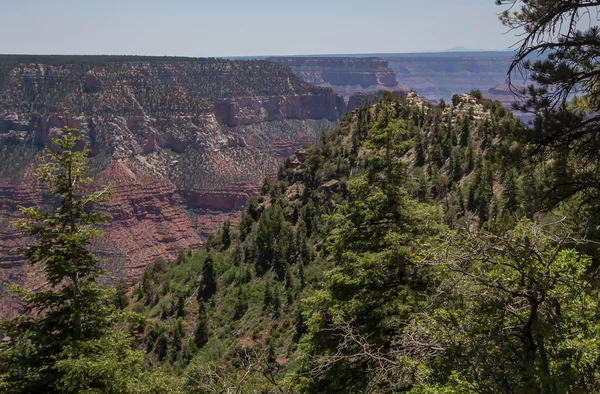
[302,103,439,392]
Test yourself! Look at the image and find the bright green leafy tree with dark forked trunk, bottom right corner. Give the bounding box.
[399,221,600,393]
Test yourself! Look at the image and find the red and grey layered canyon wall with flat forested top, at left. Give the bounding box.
[0,56,346,312]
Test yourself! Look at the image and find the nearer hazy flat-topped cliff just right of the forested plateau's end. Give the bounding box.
[269,57,408,99]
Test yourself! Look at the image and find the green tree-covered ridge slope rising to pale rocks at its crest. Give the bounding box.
[122,87,595,392]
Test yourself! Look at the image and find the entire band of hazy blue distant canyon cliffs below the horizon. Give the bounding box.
[268,51,523,106]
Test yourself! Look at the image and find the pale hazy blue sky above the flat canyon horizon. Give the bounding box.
[0,0,516,56]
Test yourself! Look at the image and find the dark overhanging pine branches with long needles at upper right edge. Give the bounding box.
[497,0,600,215]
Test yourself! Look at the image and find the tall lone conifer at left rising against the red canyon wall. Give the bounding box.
[0,112,115,393]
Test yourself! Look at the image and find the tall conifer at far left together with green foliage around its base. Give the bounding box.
[0,113,171,393]
